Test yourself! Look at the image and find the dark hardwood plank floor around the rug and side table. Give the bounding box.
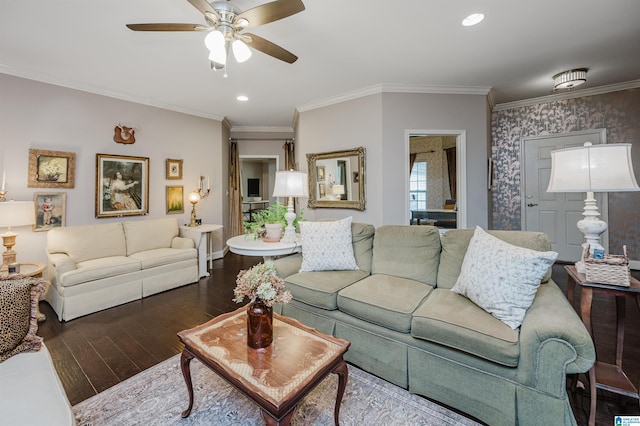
[38,253,640,426]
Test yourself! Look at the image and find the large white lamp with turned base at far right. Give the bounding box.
[547,142,640,273]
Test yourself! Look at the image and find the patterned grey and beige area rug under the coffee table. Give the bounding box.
[73,355,478,426]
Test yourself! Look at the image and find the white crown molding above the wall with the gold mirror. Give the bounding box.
[296,84,491,112]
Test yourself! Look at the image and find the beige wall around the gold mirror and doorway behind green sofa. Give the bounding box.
[296,93,489,227]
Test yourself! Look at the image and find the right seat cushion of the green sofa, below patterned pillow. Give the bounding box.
[411,288,520,367]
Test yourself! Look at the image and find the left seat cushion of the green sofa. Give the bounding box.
[285,270,369,310]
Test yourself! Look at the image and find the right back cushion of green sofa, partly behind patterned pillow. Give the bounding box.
[438,229,551,289]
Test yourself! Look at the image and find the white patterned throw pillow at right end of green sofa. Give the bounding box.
[451,226,558,330]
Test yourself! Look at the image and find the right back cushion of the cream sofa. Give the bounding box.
[122,218,178,256]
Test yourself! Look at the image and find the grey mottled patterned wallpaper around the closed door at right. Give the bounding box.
[491,88,640,259]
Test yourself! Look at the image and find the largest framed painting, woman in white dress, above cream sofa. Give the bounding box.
[96,154,149,218]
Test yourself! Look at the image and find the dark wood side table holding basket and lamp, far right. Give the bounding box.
[564,265,640,426]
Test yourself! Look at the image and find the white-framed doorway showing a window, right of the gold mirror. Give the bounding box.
[404,129,467,229]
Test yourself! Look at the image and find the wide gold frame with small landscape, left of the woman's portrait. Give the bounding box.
[27,148,76,188]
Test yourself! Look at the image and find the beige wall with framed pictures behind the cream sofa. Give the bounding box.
[0,74,226,261]
